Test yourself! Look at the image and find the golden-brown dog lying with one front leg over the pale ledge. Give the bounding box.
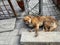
[23,15,57,36]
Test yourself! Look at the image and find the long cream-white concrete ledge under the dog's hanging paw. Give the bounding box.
[20,32,60,43]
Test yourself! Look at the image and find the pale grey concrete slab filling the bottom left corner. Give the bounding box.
[0,29,19,45]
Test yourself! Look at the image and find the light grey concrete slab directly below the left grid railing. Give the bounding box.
[0,18,16,32]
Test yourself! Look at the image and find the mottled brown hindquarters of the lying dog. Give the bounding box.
[44,16,57,32]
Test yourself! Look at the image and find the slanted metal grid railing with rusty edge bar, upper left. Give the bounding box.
[0,0,17,19]
